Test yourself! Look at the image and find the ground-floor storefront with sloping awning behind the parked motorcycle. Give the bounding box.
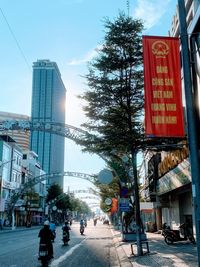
[157,159,195,232]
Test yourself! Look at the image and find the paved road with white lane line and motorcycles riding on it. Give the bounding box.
[0,222,119,267]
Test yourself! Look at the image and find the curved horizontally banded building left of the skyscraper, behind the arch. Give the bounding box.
[0,111,30,153]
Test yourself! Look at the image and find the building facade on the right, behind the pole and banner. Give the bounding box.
[143,0,200,239]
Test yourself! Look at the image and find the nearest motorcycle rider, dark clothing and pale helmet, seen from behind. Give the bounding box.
[38,221,54,259]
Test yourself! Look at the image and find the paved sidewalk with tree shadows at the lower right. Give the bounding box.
[111,229,198,267]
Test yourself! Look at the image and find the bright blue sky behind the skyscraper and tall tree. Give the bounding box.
[0,0,177,194]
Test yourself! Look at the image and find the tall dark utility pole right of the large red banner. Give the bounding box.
[178,0,200,267]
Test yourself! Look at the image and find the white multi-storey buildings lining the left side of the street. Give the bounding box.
[0,135,47,226]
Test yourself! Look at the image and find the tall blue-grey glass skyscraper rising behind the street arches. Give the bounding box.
[30,60,66,187]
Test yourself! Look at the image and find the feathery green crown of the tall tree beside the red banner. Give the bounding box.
[80,13,144,155]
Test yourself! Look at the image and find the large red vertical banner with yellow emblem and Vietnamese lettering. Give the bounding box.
[142,36,184,137]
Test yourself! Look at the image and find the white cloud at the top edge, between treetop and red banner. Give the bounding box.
[133,0,171,29]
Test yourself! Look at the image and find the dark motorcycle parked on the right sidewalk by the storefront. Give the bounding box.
[162,223,196,245]
